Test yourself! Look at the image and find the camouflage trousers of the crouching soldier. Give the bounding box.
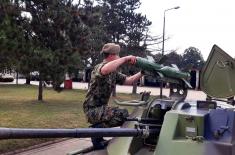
[85,106,129,128]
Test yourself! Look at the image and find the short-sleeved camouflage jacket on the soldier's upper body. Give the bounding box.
[83,61,126,113]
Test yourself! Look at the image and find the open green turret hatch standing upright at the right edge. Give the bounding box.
[200,45,235,98]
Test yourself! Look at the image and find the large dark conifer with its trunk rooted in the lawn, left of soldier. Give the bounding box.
[21,0,90,100]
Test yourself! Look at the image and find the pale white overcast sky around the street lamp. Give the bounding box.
[139,0,235,60]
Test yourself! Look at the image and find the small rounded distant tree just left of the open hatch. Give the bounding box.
[181,47,205,70]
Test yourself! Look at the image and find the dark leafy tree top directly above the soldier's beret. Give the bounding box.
[98,0,151,45]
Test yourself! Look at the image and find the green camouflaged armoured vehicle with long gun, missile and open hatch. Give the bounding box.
[0,45,235,155]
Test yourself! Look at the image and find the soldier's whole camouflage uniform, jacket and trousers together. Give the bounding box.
[83,61,128,127]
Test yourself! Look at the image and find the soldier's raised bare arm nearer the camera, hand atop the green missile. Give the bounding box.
[100,55,136,75]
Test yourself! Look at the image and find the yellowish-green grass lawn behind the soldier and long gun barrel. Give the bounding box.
[0,85,138,153]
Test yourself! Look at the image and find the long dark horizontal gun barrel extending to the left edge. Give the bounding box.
[0,128,160,139]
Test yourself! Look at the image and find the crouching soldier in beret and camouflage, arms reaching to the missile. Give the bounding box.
[83,43,142,149]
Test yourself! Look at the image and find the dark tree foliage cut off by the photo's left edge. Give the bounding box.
[0,1,25,71]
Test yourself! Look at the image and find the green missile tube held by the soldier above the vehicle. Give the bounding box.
[135,57,190,80]
